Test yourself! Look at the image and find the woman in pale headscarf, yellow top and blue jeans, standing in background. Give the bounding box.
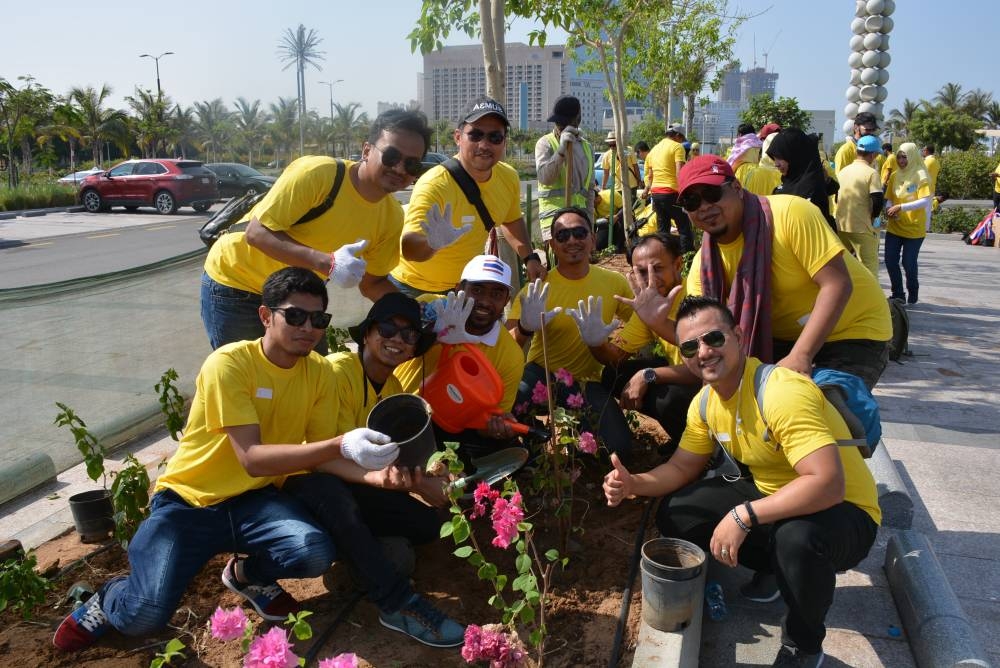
[885,142,932,304]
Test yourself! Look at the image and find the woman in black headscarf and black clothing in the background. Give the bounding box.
[767,128,837,231]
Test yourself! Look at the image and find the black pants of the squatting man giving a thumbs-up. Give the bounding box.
[656,477,878,654]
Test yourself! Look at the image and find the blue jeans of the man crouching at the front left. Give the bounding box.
[100,487,336,636]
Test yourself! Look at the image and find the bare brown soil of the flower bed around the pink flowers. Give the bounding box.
[0,256,666,668]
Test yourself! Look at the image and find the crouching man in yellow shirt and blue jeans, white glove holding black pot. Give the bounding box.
[53,267,399,651]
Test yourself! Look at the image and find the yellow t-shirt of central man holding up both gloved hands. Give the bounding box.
[510,266,632,380]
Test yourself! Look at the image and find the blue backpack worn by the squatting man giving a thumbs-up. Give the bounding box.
[699,364,882,459]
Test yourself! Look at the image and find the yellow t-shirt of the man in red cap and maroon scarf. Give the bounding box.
[686,195,892,341]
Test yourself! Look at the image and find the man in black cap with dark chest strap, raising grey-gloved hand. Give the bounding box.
[390,97,545,297]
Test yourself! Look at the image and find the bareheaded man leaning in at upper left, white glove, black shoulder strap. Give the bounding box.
[201,109,431,352]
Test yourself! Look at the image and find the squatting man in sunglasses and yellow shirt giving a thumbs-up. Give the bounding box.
[604,297,882,666]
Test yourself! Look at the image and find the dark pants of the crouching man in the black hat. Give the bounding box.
[282,473,441,612]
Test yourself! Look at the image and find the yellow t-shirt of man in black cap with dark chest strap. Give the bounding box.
[392,162,521,292]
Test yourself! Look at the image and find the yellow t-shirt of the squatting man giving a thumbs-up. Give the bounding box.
[680,357,882,523]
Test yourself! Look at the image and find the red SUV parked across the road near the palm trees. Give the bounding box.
[80,158,219,214]
